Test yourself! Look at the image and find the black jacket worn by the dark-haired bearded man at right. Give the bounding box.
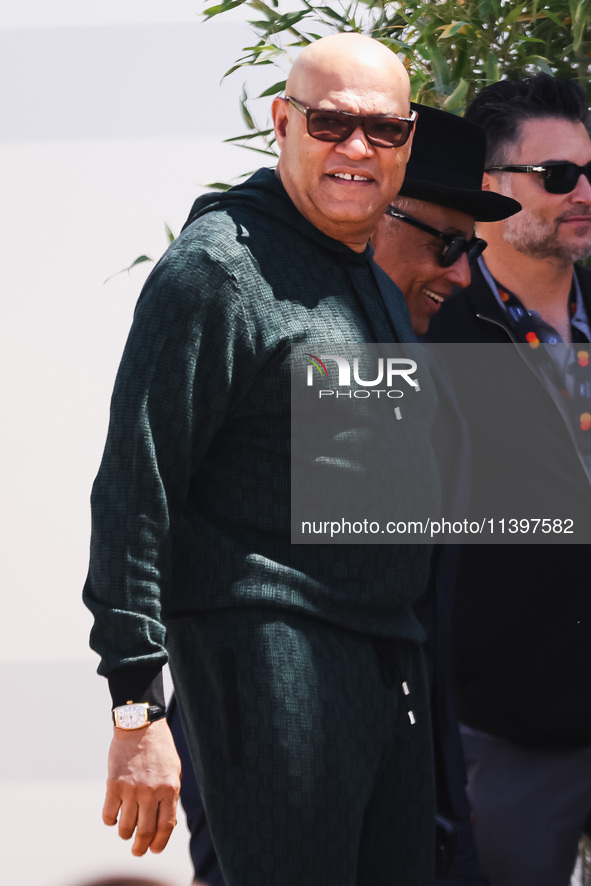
[428,260,591,749]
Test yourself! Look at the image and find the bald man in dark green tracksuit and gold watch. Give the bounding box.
[84,34,438,886]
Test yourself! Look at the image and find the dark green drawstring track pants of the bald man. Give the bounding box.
[167,609,435,886]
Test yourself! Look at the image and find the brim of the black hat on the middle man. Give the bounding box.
[400,176,521,221]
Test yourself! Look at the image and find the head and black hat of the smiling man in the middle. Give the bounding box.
[371,104,519,336]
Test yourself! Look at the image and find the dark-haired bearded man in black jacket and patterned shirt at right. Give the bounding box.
[428,75,591,886]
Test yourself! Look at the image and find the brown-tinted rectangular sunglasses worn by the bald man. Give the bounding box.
[284,95,417,148]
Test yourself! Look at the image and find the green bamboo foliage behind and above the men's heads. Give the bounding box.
[204,0,591,163]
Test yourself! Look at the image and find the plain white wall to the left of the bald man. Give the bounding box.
[0,0,278,886]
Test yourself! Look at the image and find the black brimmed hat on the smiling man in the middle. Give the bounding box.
[400,102,521,221]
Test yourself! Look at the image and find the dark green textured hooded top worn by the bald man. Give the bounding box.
[84,169,438,704]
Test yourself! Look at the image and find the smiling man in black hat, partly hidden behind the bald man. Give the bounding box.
[169,104,519,886]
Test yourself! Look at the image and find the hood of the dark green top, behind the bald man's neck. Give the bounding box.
[183,169,373,264]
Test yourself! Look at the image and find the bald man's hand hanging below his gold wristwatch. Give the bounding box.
[103,720,181,855]
